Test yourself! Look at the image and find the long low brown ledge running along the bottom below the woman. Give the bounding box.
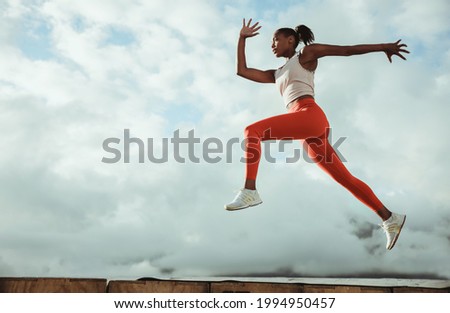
[0,277,450,293]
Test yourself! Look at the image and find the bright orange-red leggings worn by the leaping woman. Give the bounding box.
[245,98,383,212]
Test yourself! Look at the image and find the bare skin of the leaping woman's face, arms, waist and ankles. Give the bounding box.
[237,19,409,221]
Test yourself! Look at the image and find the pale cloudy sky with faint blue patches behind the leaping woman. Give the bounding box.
[0,0,450,279]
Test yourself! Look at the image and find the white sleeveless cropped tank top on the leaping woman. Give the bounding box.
[275,52,314,107]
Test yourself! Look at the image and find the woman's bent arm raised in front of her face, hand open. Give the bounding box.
[237,19,275,83]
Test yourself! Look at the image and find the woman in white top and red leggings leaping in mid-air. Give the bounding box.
[225,19,409,250]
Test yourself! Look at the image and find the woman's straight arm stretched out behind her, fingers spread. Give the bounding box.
[303,40,409,63]
